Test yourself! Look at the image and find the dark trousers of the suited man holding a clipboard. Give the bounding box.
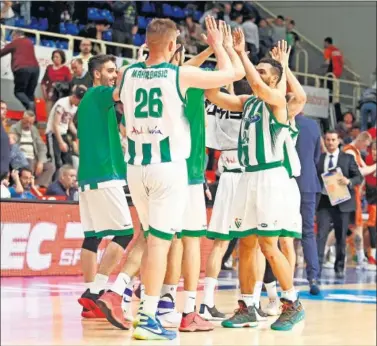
[317,195,350,272]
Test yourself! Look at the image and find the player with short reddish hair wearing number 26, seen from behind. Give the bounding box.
[97,17,242,340]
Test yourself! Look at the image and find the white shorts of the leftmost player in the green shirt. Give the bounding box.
[79,186,133,238]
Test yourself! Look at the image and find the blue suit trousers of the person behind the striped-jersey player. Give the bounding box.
[300,192,319,281]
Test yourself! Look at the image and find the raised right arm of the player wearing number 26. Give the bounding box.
[179,16,236,89]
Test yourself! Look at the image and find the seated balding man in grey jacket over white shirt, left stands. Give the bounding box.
[10,111,55,187]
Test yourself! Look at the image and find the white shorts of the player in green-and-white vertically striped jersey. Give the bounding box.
[230,167,301,238]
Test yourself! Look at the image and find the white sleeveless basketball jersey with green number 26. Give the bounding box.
[120,63,191,165]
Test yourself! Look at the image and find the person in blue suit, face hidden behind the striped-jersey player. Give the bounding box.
[295,114,321,295]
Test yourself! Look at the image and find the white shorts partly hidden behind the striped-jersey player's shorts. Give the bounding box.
[207,172,242,240]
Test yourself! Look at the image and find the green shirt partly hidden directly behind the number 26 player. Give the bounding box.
[185,88,206,185]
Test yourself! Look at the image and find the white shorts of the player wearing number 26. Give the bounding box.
[127,161,188,240]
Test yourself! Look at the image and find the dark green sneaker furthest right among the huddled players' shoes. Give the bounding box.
[271,298,305,331]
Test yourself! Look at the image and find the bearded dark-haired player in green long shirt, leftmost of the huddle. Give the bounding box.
[77,55,133,318]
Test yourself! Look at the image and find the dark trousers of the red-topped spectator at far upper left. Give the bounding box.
[13,67,39,111]
